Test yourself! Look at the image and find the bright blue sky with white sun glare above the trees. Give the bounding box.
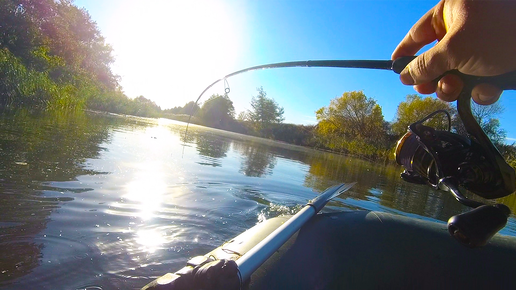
[74,0,516,143]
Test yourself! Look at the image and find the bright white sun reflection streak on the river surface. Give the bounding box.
[98,119,191,263]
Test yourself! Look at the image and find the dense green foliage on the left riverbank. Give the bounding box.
[0,0,161,116]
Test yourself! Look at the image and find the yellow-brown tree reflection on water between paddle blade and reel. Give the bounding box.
[305,153,486,221]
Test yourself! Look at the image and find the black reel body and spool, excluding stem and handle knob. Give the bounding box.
[396,115,514,199]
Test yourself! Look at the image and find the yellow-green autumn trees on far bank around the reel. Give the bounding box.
[316,91,514,159]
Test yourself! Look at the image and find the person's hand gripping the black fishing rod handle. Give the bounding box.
[392,0,516,105]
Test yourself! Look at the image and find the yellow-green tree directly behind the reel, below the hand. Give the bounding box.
[391,95,455,136]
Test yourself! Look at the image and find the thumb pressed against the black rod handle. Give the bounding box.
[400,42,452,85]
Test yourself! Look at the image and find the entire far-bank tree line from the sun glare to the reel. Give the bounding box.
[164,87,516,166]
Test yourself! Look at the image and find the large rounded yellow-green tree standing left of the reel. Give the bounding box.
[316,91,386,156]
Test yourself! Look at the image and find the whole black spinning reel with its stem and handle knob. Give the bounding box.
[395,86,516,247]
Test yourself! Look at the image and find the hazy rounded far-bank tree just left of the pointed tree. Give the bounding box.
[200,95,235,128]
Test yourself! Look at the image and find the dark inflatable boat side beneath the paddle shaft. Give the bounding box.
[143,211,516,290]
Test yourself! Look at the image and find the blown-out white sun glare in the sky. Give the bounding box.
[105,0,242,108]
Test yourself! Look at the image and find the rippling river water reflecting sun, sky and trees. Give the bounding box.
[0,112,516,289]
